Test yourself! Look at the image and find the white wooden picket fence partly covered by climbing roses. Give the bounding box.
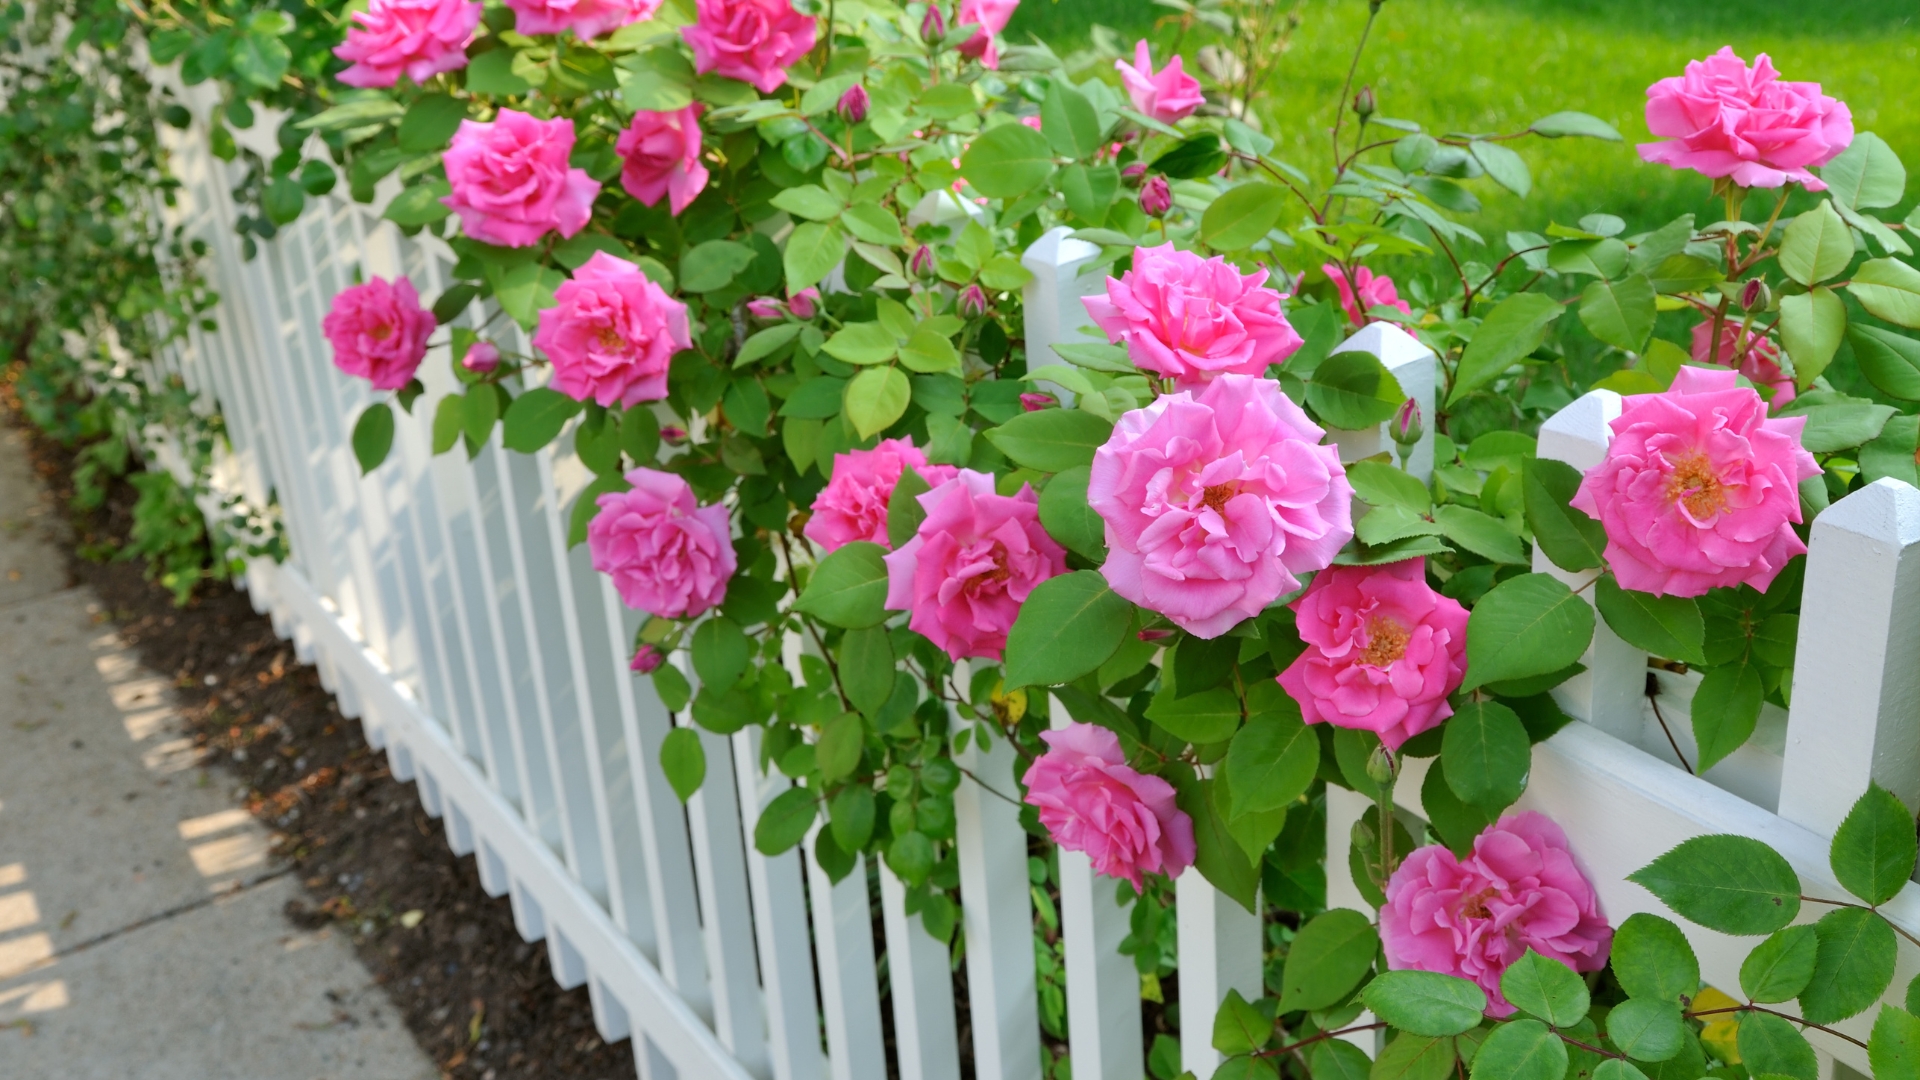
[131,77,1920,1080]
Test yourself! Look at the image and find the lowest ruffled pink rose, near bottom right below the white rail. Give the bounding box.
[1380,811,1613,1017]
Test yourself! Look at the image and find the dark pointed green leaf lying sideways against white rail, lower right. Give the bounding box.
[1626,834,1799,934]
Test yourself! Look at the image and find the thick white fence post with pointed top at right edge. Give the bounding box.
[1780,479,1920,836]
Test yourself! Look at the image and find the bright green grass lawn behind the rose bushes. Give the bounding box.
[1008,0,1920,242]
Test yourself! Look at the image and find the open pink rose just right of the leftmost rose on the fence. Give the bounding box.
[534,252,693,405]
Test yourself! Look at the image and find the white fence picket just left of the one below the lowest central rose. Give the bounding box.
[954,722,1041,1080]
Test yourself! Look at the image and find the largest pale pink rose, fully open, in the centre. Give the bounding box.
[1087,375,1354,638]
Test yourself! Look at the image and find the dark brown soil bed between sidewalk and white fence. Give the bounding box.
[0,386,634,1080]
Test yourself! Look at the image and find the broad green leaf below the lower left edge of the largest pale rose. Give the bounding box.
[1006,571,1121,684]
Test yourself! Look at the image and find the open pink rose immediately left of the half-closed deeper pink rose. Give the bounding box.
[440,110,599,248]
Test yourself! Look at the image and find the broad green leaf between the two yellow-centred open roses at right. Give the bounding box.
[1461,575,1594,690]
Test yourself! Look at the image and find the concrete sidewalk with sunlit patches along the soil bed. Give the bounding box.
[0,429,438,1080]
